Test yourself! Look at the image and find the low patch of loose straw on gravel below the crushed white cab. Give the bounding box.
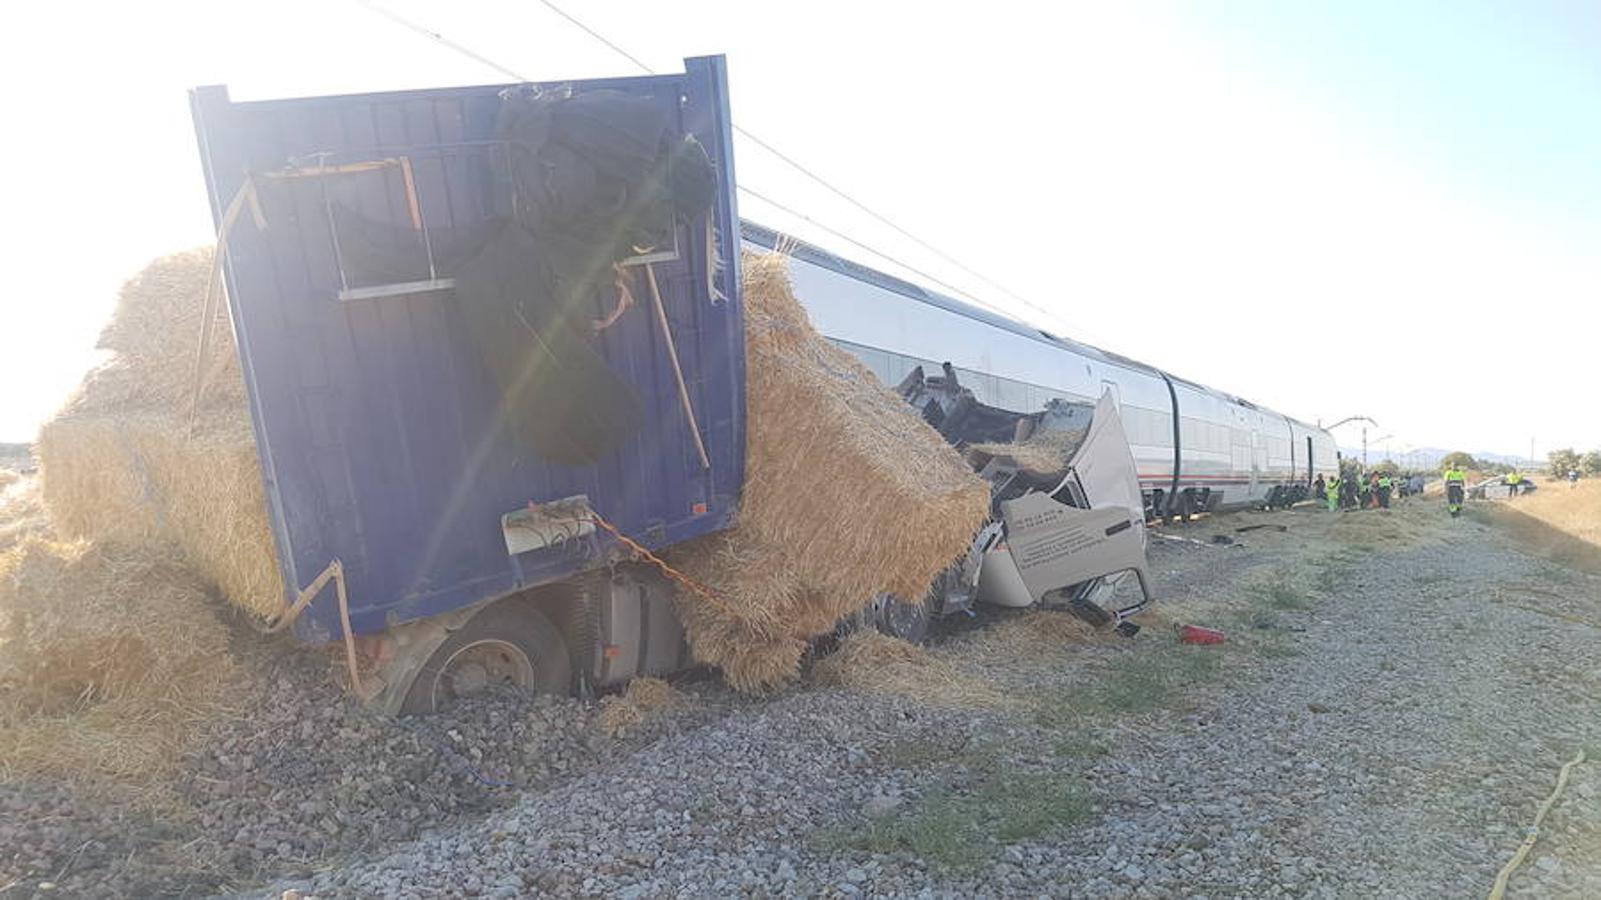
[812,631,1005,708]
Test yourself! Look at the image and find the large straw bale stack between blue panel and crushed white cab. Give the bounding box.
[676,255,989,690]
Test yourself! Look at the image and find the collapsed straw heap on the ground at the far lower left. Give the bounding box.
[0,536,234,785]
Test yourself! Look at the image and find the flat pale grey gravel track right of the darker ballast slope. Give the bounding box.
[275,508,1601,897]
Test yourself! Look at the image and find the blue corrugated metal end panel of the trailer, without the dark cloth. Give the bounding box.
[192,58,744,639]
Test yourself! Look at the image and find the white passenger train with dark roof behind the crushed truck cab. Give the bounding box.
[743,221,1338,517]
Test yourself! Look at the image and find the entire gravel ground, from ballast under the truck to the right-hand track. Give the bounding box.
[0,493,1601,897]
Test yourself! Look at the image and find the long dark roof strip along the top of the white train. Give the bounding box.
[740,219,1322,431]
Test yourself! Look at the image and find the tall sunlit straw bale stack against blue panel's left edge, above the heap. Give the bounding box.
[37,251,285,618]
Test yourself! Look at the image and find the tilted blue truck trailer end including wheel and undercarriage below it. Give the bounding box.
[191,56,744,713]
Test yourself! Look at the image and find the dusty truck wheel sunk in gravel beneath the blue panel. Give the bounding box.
[400,601,573,716]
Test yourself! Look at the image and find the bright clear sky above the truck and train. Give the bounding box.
[0,0,1601,455]
